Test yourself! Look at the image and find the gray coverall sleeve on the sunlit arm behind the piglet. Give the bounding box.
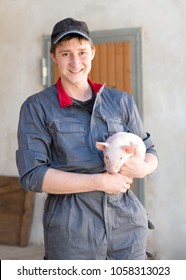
[124,95,157,156]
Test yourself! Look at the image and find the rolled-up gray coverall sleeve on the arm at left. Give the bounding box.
[16,98,51,192]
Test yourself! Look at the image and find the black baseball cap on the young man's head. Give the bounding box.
[51,18,91,44]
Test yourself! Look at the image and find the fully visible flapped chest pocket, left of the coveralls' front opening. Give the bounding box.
[48,118,91,165]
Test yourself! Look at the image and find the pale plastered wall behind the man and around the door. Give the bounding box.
[0,0,186,259]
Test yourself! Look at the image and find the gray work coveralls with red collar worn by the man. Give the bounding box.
[16,77,156,260]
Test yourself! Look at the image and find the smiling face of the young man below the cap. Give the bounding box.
[51,38,95,86]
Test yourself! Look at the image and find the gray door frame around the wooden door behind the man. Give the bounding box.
[42,27,145,205]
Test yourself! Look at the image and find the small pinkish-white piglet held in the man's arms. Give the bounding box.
[96,132,146,174]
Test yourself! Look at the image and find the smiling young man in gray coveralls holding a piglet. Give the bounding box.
[16,18,158,260]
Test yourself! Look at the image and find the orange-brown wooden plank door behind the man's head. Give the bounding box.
[89,42,131,93]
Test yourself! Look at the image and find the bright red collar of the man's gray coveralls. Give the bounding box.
[56,78,103,108]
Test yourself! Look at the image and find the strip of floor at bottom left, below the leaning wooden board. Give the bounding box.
[0,244,44,260]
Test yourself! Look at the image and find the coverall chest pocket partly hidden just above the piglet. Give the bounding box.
[106,118,129,137]
